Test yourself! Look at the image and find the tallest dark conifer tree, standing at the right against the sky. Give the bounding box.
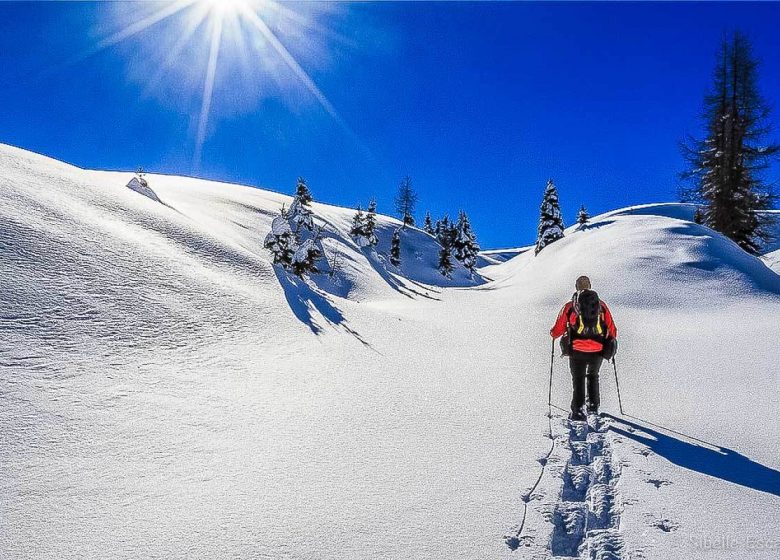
[682,32,780,254]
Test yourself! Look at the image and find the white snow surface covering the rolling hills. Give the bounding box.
[0,146,780,560]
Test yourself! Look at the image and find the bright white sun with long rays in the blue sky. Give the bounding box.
[86,0,346,171]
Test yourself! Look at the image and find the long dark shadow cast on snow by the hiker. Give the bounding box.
[604,414,780,496]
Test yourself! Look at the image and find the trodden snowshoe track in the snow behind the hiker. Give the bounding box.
[550,415,624,560]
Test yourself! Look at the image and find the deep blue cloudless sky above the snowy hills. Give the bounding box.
[0,2,780,247]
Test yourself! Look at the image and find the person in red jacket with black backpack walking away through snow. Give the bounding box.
[550,276,617,420]
